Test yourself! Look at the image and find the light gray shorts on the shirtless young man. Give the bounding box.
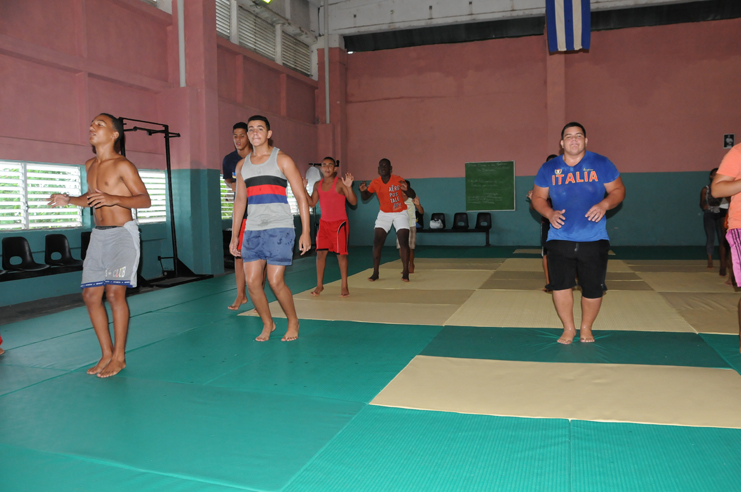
[82,220,140,289]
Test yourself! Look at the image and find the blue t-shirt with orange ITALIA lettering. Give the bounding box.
[535,151,620,242]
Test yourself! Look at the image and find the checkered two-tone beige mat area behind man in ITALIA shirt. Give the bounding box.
[242,258,724,333]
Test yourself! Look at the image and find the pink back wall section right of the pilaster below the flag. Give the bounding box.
[566,19,741,172]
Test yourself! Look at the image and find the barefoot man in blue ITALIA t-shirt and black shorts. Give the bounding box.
[532,122,625,344]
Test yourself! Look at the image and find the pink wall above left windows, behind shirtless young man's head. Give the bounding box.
[0,0,177,169]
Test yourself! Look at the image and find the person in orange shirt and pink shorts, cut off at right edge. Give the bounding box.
[710,144,741,351]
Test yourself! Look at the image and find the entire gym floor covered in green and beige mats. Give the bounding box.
[0,247,741,492]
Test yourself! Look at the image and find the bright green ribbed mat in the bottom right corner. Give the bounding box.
[571,420,741,492]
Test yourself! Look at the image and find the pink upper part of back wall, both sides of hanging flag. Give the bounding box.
[346,19,741,183]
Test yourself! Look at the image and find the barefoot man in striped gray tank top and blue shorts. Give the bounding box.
[230,116,311,342]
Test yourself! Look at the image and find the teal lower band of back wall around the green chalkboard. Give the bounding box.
[348,171,708,246]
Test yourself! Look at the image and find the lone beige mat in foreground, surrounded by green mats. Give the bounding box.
[371,356,741,429]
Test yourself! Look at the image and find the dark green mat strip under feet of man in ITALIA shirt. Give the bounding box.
[421,326,738,368]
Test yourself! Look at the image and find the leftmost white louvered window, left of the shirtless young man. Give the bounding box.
[0,161,82,230]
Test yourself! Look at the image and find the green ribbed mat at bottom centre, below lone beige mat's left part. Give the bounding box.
[286,406,570,492]
